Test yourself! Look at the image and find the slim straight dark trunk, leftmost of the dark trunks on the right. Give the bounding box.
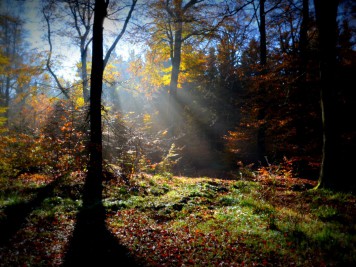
[257,0,267,164]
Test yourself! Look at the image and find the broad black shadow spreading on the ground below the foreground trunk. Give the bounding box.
[62,177,142,267]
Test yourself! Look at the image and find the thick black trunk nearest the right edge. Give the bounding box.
[314,0,341,191]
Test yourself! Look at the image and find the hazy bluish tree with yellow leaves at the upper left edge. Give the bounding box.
[0,14,43,129]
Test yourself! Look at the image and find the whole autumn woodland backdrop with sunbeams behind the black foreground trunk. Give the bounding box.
[0,0,356,189]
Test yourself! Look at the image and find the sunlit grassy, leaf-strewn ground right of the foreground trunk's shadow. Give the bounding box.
[104,176,356,266]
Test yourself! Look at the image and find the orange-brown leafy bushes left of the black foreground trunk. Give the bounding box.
[0,97,86,176]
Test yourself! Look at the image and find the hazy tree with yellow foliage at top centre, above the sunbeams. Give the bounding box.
[146,0,221,136]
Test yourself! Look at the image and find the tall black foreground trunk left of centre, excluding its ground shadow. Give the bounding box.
[85,0,107,203]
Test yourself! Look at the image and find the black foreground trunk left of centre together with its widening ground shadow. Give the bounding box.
[63,0,141,266]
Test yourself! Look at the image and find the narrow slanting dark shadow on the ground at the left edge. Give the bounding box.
[0,176,64,246]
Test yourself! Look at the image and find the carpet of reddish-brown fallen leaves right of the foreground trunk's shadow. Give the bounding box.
[107,209,248,266]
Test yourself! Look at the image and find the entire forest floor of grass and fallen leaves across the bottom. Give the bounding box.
[0,172,356,267]
